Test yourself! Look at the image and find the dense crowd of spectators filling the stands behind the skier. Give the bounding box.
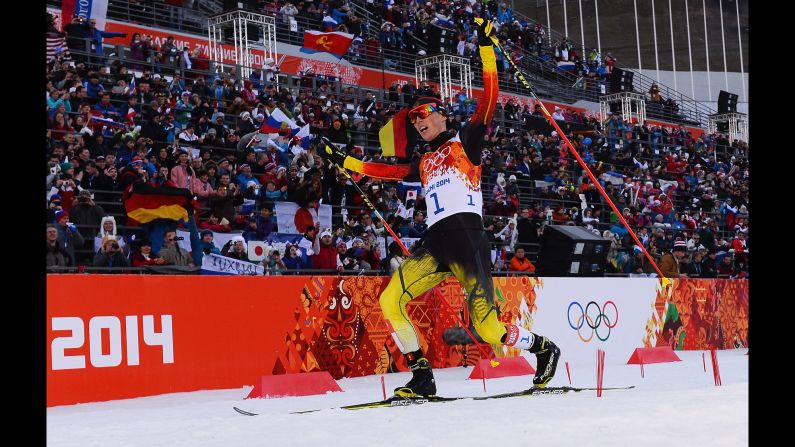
[46,1,748,277]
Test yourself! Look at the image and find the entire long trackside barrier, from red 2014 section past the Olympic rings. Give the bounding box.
[47,274,748,406]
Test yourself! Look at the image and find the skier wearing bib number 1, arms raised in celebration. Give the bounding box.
[319,19,560,397]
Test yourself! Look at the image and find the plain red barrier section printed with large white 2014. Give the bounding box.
[47,275,305,405]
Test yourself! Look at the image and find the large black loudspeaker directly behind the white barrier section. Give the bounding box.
[538,225,611,276]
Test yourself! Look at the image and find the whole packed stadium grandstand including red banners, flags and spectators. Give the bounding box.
[45,0,750,278]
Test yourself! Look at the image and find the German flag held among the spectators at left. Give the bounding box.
[122,183,194,223]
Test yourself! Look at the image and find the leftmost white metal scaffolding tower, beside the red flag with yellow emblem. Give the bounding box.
[207,9,277,78]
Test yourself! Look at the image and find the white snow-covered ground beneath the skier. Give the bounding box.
[47,349,749,447]
